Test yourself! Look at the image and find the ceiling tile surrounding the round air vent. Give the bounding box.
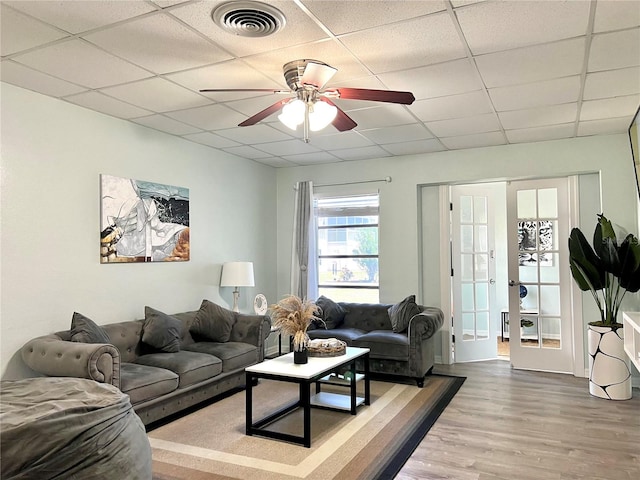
[171,0,327,60]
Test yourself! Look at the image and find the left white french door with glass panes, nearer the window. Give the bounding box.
[451,185,497,362]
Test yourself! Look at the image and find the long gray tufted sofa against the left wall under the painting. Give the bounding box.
[22,300,271,425]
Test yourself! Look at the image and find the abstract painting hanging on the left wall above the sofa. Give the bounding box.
[100,175,190,263]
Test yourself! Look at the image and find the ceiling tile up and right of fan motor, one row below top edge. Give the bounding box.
[340,12,466,74]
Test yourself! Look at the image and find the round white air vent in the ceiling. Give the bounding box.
[211,2,287,37]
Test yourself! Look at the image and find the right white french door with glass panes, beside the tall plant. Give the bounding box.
[502,179,573,373]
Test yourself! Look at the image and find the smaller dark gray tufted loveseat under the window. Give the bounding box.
[308,295,444,387]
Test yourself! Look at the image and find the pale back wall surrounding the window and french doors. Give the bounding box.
[277,134,640,364]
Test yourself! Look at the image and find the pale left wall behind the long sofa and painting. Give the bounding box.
[0,83,276,379]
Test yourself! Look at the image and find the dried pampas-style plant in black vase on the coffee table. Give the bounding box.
[270,295,322,363]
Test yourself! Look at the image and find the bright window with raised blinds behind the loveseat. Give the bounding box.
[314,195,380,303]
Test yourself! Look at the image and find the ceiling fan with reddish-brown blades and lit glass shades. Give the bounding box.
[200,60,415,142]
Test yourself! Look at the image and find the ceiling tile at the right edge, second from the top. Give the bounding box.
[588,28,640,72]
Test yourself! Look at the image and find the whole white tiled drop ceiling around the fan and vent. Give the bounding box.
[0,0,640,167]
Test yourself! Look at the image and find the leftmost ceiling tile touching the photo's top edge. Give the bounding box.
[3,0,155,33]
